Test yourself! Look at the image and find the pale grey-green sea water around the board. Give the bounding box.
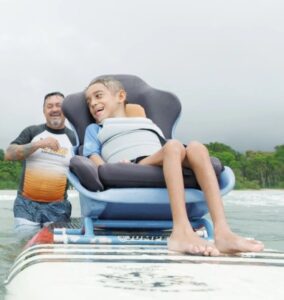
[0,190,284,300]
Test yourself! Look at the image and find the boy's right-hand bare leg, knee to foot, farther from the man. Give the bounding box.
[184,142,263,253]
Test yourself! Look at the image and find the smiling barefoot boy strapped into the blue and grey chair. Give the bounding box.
[83,77,263,256]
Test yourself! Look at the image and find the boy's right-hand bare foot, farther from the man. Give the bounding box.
[215,230,264,254]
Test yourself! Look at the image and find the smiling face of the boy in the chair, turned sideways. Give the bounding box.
[85,83,126,123]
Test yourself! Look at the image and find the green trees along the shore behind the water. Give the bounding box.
[0,142,284,189]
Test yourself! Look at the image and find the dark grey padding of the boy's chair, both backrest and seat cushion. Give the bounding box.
[63,75,223,191]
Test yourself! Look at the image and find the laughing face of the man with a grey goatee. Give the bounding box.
[43,95,65,129]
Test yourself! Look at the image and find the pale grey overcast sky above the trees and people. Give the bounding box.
[0,0,284,151]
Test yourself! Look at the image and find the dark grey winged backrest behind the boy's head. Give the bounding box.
[62,75,181,145]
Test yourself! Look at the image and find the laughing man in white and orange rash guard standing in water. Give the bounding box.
[5,92,76,236]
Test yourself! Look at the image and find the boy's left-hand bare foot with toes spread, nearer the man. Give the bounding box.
[168,232,220,256]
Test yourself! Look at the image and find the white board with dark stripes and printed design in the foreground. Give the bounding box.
[5,244,284,300]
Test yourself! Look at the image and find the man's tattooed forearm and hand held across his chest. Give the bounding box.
[5,137,60,160]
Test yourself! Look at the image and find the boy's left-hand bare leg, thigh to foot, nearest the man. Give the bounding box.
[139,140,219,255]
